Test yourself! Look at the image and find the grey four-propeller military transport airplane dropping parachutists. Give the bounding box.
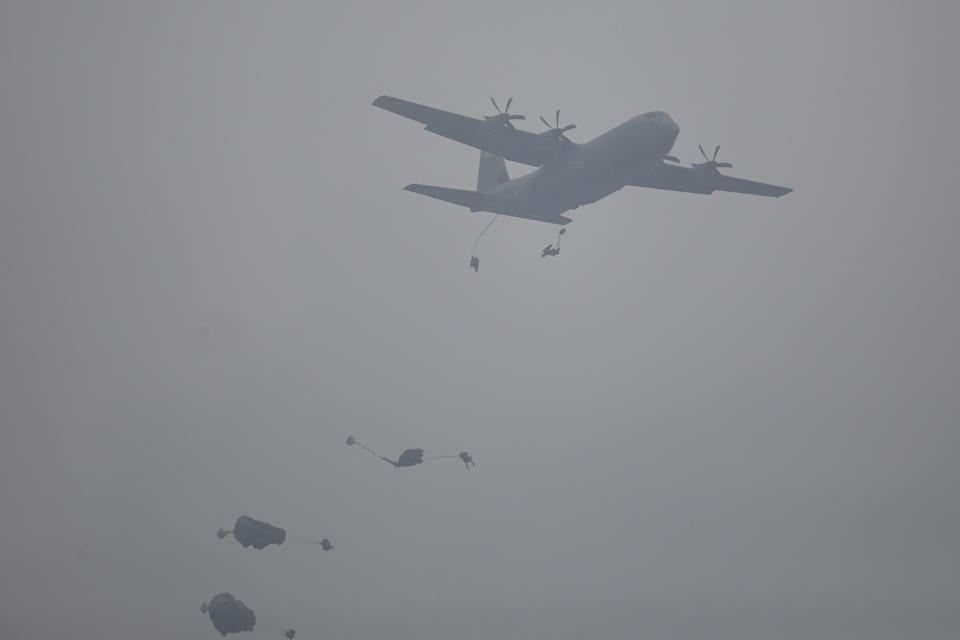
[373,96,793,224]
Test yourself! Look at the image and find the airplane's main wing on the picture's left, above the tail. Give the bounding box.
[373,96,549,167]
